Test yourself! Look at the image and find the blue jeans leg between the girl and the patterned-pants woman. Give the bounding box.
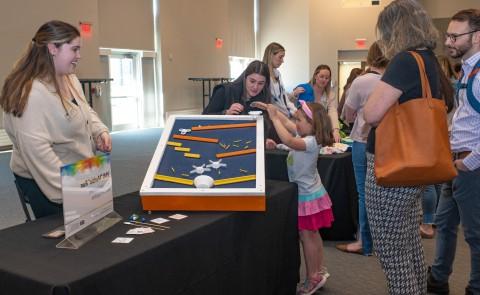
[352,141,373,255]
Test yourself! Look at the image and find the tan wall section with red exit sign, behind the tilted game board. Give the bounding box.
[157,0,254,117]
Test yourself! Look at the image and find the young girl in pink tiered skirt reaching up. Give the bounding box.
[255,101,334,295]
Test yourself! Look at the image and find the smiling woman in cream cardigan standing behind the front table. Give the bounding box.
[0,21,111,218]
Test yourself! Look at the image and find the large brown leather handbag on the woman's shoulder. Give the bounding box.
[375,51,457,186]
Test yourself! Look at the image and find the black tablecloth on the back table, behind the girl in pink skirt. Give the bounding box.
[265,150,358,240]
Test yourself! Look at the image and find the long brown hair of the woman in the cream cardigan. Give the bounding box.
[0,20,80,117]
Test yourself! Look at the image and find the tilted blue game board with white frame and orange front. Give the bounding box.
[140,115,265,211]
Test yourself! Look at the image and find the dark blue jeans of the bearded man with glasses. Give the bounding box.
[432,168,480,294]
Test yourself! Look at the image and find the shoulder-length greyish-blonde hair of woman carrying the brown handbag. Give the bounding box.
[377,0,438,59]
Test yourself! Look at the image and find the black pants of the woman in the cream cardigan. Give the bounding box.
[13,174,63,219]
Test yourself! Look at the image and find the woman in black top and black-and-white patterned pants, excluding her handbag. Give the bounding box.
[364,0,453,295]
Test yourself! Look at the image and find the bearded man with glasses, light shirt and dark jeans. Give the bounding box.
[428,9,480,294]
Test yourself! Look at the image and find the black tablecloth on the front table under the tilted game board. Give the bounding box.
[0,181,300,295]
